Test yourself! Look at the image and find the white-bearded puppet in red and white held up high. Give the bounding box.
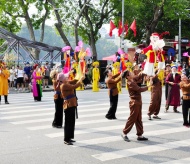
[142,33,165,76]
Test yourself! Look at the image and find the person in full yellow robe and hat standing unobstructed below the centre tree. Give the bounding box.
[92,61,100,92]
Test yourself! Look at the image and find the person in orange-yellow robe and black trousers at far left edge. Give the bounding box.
[0,64,10,104]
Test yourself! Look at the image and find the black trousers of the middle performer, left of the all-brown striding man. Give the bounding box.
[106,94,118,118]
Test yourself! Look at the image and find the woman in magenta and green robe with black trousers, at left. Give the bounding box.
[32,64,42,101]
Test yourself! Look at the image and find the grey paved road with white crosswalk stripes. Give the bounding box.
[0,88,190,164]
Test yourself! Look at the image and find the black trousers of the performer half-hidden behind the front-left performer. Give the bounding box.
[52,94,63,126]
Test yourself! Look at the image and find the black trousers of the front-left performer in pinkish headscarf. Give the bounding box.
[64,107,76,142]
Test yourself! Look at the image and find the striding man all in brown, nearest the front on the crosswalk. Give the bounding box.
[121,70,151,142]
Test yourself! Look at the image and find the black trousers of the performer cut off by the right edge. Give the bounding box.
[182,100,190,125]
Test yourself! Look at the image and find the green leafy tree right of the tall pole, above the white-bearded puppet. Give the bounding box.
[114,0,190,44]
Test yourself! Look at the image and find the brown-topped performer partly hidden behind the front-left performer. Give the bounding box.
[50,69,63,128]
